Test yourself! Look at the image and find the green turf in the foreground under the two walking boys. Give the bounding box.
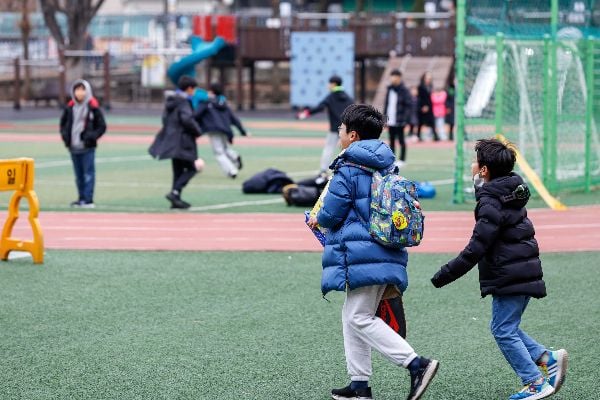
[0,251,600,400]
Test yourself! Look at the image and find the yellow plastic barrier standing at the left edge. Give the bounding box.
[0,158,44,264]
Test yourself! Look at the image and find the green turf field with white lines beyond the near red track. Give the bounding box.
[0,113,600,212]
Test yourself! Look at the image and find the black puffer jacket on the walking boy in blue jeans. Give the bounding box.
[431,173,546,298]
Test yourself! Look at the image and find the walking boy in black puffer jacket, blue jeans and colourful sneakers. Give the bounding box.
[431,139,568,400]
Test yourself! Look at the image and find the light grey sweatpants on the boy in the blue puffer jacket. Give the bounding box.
[342,285,417,381]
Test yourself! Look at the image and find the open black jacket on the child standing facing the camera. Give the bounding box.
[60,97,106,149]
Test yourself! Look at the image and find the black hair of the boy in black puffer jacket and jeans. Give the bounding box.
[475,139,517,179]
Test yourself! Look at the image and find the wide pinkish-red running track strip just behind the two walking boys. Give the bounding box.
[0,206,600,253]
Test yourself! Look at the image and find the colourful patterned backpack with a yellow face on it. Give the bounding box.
[345,162,425,248]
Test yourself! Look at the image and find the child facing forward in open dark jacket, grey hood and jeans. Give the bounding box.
[60,79,106,208]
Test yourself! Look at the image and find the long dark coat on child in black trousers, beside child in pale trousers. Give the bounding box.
[148,94,202,161]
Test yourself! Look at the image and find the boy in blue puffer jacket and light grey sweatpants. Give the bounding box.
[308,104,439,400]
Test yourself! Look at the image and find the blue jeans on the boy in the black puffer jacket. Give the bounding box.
[490,296,546,385]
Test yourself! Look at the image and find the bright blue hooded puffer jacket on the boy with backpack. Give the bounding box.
[317,140,408,295]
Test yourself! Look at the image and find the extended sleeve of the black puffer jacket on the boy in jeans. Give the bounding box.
[431,203,501,287]
